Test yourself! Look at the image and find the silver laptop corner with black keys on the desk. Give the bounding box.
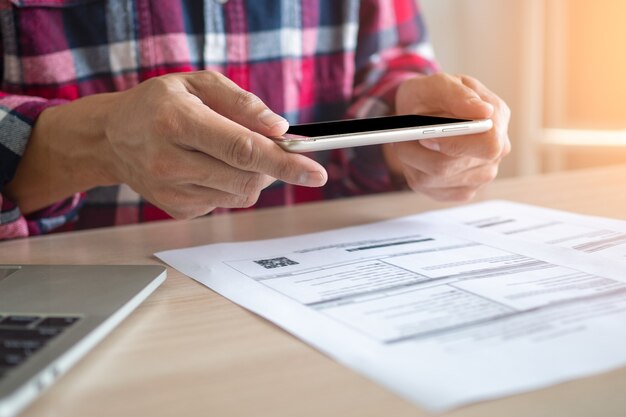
[0,265,166,417]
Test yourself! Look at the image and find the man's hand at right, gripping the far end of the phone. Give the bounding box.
[383,74,511,201]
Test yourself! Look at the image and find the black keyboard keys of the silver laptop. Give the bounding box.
[0,313,80,379]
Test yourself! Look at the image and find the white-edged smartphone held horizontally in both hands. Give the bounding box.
[272,114,493,153]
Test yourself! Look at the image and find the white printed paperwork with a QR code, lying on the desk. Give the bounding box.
[156,201,626,412]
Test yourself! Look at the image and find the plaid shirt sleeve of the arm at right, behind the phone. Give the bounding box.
[329,0,439,196]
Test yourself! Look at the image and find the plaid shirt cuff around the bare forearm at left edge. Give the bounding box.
[0,92,82,240]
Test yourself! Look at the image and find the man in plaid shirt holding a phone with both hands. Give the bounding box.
[0,0,510,239]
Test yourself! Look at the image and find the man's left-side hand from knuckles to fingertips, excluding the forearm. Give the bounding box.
[106,72,326,218]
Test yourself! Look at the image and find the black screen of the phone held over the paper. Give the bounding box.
[287,114,469,137]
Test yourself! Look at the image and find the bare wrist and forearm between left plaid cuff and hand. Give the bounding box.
[6,94,122,214]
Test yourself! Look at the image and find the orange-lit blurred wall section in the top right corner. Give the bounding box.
[544,0,626,130]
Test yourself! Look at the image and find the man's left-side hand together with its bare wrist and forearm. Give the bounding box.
[9,71,327,218]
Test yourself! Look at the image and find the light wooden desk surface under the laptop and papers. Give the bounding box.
[0,166,626,417]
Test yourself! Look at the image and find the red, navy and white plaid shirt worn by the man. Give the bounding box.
[0,0,436,239]
